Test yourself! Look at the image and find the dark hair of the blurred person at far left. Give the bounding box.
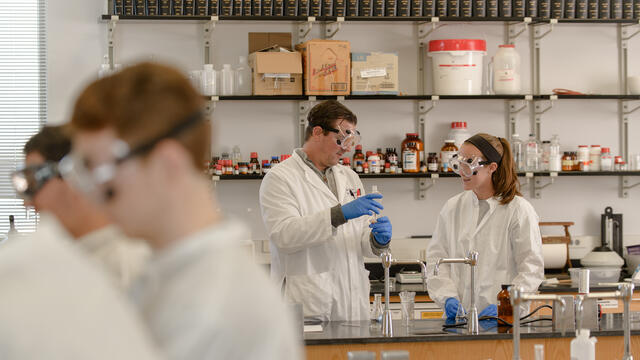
[23,125,71,161]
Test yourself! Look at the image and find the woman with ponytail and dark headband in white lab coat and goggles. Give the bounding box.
[427,134,544,319]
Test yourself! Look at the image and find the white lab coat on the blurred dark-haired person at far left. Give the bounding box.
[76,225,151,289]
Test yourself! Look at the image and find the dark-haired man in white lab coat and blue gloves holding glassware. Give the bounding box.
[260,101,391,321]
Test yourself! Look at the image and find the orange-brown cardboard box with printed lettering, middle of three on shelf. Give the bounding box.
[296,39,351,95]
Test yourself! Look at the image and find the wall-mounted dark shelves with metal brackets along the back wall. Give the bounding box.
[101,15,640,199]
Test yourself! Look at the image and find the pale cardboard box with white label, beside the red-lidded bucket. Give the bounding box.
[351,52,398,95]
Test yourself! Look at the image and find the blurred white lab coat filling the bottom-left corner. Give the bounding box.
[0,213,160,360]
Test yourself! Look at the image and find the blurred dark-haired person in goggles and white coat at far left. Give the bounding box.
[14,126,150,289]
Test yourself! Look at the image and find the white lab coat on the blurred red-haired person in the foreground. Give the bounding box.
[132,220,302,360]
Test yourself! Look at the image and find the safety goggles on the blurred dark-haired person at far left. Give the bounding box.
[11,162,60,200]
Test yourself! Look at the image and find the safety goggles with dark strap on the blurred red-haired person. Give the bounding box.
[58,111,203,202]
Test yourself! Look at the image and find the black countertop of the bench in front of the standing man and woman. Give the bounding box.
[304,313,640,345]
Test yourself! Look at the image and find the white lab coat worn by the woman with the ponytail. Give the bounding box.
[427,191,544,312]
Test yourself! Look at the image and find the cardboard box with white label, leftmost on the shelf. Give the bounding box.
[249,48,302,95]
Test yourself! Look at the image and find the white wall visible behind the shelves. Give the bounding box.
[48,0,640,258]
